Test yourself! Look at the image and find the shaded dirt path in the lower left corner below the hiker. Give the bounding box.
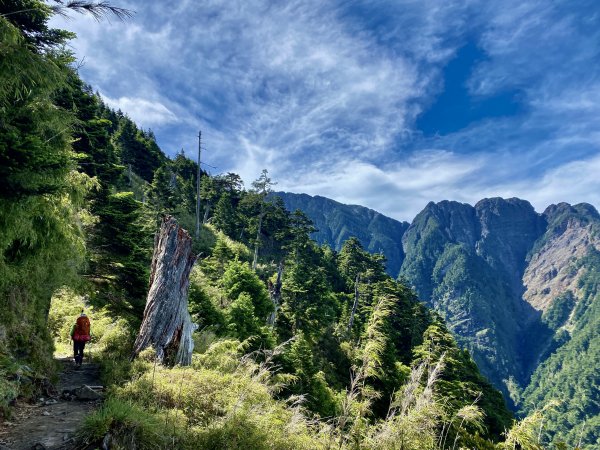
[0,358,101,450]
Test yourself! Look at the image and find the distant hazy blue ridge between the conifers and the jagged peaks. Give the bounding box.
[274,192,408,277]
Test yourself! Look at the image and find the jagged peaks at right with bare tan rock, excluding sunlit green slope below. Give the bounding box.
[401,198,600,408]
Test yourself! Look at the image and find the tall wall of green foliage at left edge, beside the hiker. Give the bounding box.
[0,9,95,408]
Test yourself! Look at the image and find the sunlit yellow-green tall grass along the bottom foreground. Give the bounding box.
[80,308,556,450]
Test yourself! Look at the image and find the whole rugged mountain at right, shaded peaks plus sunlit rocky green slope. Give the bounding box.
[282,192,600,444]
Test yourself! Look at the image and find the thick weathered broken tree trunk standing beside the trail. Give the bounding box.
[132,216,197,365]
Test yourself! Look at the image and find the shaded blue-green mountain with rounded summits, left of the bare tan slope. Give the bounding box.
[401,198,544,402]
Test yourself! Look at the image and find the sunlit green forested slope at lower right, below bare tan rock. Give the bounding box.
[521,249,600,450]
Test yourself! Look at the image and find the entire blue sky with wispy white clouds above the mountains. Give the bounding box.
[53,0,600,220]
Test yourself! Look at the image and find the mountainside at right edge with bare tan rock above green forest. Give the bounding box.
[519,203,600,448]
